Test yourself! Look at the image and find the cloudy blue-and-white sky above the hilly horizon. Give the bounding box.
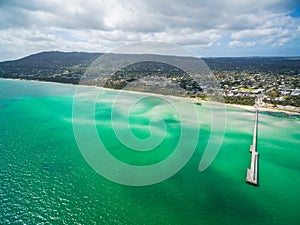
[0,0,300,61]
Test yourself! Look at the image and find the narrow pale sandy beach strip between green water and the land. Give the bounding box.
[0,77,300,116]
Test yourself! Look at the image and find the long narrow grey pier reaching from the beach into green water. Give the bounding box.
[246,109,258,186]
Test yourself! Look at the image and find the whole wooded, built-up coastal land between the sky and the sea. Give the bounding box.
[0,51,300,114]
